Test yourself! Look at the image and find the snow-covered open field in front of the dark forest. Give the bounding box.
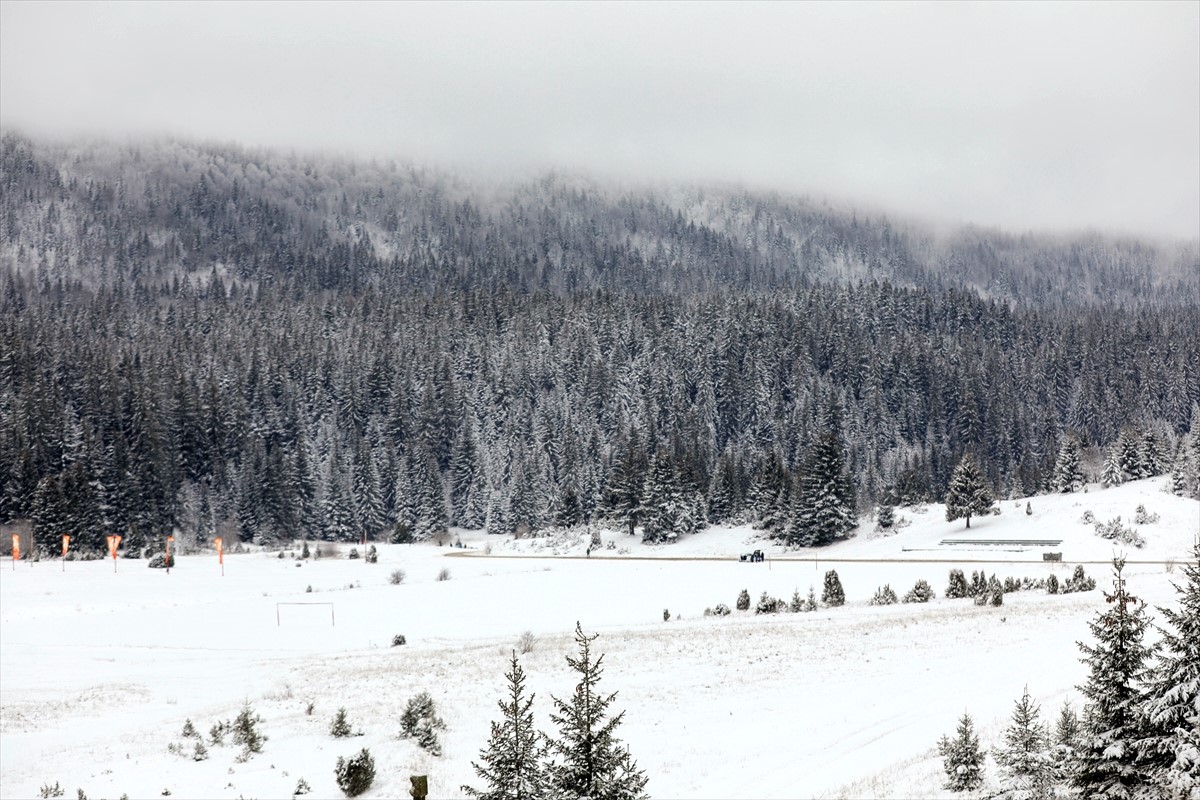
[0,479,1200,799]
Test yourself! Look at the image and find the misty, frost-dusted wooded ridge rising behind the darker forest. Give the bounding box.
[0,131,1200,308]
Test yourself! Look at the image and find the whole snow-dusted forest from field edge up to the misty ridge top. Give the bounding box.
[0,132,1200,551]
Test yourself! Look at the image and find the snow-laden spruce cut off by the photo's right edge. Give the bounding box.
[1138,541,1200,798]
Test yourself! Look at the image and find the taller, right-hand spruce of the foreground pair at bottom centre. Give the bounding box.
[547,622,648,800]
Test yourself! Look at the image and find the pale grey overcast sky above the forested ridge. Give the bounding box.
[0,0,1200,239]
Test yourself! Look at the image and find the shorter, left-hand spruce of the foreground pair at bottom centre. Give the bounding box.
[462,651,546,800]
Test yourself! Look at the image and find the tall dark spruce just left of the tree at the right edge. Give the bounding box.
[1073,558,1150,799]
